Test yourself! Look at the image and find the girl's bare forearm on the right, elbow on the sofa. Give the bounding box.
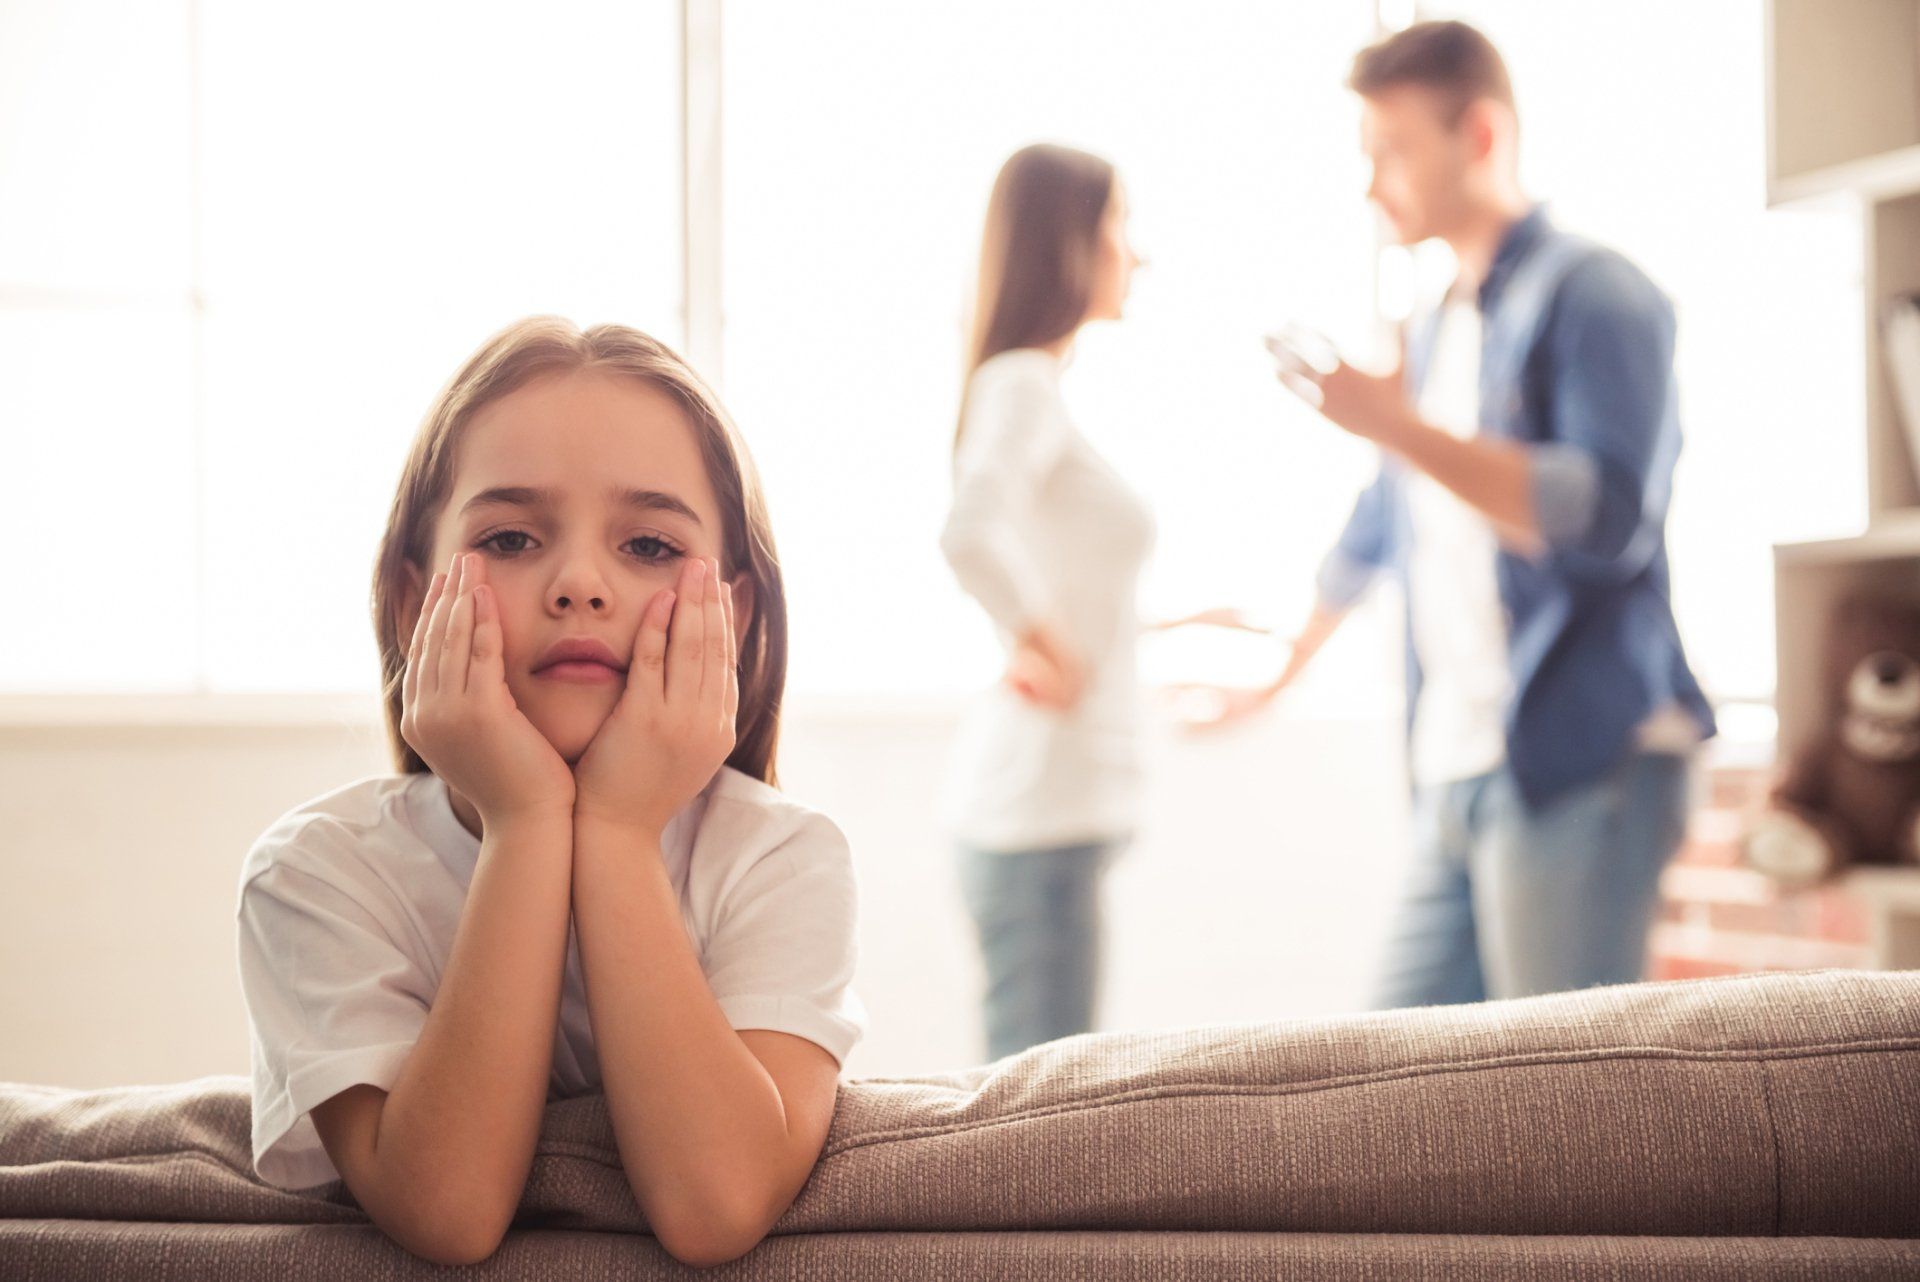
[574,823,812,1263]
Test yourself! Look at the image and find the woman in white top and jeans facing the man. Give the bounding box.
[941,146,1154,1057]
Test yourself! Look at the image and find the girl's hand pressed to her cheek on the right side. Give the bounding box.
[574,558,739,837]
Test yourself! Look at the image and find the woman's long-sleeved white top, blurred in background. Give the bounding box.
[941,349,1154,852]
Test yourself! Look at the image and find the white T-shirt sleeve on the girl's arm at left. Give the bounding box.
[238,864,432,1188]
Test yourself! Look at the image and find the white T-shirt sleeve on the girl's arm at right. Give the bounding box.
[703,814,866,1063]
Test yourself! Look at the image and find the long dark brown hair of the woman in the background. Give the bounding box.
[954,144,1114,447]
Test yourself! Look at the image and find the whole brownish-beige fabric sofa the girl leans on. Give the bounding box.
[0,971,1920,1282]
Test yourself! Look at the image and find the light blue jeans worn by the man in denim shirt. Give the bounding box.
[1375,752,1688,1009]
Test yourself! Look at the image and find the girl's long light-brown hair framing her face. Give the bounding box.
[372,317,787,783]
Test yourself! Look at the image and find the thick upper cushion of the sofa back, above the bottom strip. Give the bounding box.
[0,971,1920,1238]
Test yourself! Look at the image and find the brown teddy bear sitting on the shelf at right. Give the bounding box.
[1743,597,1920,885]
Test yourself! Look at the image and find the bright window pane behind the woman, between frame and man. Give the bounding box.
[724,0,1373,691]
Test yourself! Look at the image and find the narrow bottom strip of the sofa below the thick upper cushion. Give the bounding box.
[0,1219,1920,1282]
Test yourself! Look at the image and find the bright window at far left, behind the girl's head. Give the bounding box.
[0,0,680,691]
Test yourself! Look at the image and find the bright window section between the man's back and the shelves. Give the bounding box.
[1423,0,1866,699]
